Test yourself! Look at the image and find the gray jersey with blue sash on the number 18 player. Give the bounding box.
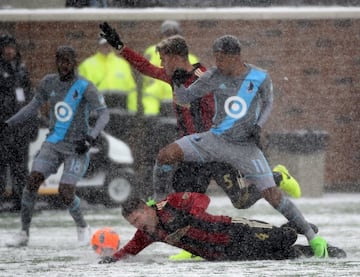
[35,74,106,143]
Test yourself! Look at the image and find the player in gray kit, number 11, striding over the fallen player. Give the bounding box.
[154,35,328,257]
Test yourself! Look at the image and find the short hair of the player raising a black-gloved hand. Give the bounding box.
[156,35,189,57]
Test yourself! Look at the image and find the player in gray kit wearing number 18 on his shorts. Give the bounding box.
[2,46,109,247]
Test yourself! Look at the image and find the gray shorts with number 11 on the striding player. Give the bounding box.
[175,132,276,191]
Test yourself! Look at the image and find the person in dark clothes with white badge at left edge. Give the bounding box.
[0,34,38,211]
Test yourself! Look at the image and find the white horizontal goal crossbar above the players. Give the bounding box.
[0,6,360,22]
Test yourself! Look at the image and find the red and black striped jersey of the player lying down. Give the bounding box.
[114,192,232,260]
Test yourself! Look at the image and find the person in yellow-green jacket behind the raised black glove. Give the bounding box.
[78,38,137,111]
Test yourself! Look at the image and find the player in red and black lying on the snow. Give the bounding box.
[100,192,346,263]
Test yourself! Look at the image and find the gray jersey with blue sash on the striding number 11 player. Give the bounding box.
[175,64,273,142]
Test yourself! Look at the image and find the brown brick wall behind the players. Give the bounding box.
[0,19,360,190]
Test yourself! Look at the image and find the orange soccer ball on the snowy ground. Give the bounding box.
[91,227,120,256]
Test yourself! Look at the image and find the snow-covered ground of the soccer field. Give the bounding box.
[0,193,360,277]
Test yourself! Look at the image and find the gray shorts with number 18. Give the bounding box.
[31,141,89,185]
